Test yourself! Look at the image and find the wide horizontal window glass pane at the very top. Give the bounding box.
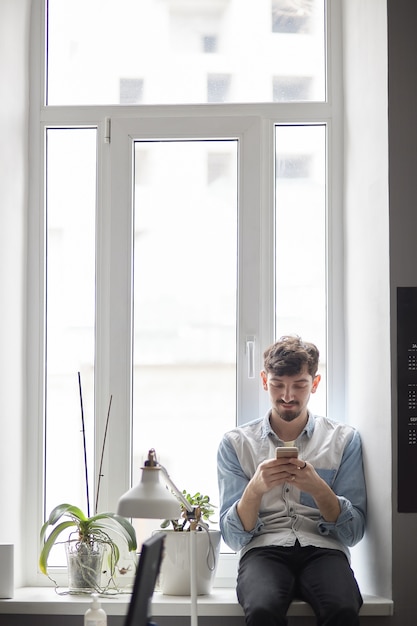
[47,0,325,105]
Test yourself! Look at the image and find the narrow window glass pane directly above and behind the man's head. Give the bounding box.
[275,125,327,415]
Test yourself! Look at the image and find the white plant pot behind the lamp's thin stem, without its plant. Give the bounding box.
[157,530,221,596]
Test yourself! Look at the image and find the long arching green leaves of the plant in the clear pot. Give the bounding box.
[39,504,137,577]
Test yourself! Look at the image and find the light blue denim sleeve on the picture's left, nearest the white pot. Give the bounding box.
[217,436,263,551]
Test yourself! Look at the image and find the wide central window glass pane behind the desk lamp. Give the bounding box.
[133,140,238,535]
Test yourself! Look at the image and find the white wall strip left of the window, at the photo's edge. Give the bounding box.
[0,0,30,584]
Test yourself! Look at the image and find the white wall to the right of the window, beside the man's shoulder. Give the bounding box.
[344,0,392,597]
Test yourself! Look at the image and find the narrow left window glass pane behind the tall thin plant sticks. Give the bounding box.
[45,129,96,565]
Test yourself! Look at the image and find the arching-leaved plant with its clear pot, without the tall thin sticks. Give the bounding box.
[39,504,137,593]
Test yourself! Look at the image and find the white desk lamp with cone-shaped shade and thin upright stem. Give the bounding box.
[117,448,201,626]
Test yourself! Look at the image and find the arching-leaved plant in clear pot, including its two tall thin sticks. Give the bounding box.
[39,373,137,593]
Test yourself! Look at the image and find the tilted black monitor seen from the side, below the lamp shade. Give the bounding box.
[124,533,165,626]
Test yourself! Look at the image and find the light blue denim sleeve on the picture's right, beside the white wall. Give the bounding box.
[318,431,366,547]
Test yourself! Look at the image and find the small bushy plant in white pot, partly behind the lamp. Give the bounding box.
[159,490,221,596]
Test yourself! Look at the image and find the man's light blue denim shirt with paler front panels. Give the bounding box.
[217,411,366,559]
